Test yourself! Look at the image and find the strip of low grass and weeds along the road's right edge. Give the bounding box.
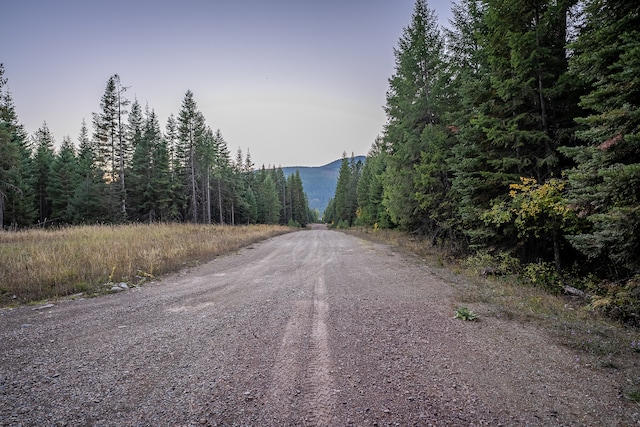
[344,227,640,403]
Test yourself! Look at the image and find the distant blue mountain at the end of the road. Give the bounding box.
[282,156,366,215]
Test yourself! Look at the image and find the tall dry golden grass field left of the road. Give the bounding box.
[0,224,290,305]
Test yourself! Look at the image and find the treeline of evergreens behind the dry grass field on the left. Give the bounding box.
[0,70,315,228]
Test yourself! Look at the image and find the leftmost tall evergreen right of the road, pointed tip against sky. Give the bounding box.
[382,0,445,231]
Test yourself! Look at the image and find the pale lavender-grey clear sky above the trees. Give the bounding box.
[0,0,451,167]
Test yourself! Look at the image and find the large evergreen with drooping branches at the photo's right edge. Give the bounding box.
[563,0,640,272]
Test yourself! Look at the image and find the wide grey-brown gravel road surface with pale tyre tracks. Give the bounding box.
[0,230,640,426]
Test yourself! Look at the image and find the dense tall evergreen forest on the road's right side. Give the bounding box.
[325,0,640,324]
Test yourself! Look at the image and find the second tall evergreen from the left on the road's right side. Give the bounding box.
[445,0,500,248]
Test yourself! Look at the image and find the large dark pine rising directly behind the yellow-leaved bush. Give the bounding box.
[454,0,576,266]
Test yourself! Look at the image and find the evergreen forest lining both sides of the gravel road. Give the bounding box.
[0,0,640,324]
